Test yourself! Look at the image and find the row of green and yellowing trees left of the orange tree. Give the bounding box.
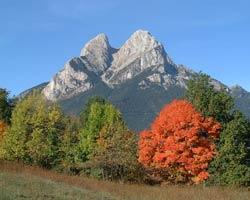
[0,92,141,181]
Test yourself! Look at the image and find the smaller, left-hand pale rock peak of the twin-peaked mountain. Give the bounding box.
[80,33,115,75]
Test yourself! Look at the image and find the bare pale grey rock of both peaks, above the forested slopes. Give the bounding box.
[43,30,198,101]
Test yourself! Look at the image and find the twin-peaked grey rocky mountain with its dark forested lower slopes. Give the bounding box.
[26,30,250,130]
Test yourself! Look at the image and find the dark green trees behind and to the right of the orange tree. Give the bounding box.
[186,73,250,185]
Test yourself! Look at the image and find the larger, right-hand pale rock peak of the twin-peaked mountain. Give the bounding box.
[102,30,171,86]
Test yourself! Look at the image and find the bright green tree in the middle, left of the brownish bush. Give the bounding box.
[78,99,122,161]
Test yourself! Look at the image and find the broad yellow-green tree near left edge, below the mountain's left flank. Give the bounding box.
[4,92,64,168]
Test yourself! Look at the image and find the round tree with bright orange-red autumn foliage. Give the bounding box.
[138,100,221,183]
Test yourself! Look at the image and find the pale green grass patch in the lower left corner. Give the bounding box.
[0,172,116,200]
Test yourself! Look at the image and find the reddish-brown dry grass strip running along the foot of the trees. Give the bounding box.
[0,162,250,200]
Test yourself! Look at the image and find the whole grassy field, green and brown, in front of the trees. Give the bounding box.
[0,162,250,200]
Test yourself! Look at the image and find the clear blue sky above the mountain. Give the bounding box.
[0,0,250,94]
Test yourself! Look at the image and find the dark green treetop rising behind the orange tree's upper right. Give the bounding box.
[185,73,234,124]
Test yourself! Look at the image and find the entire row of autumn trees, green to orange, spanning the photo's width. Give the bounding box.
[0,74,250,186]
